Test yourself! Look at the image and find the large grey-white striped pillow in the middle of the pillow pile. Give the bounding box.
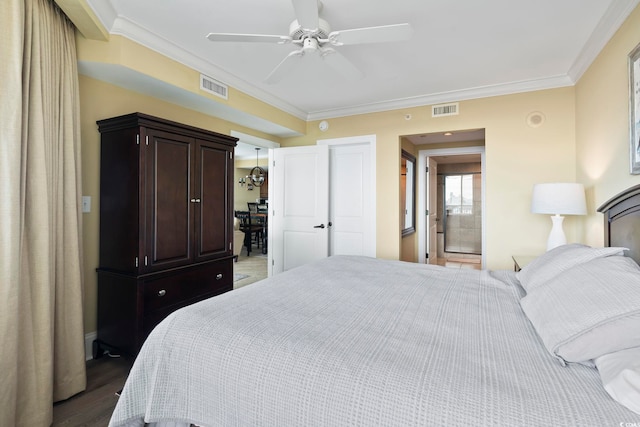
[520,256,640,362]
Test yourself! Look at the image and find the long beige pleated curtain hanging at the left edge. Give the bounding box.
[0,0,86,426]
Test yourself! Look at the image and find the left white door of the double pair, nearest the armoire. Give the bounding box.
[269,145,329,275]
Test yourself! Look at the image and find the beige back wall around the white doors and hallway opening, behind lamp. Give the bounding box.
[282,87,577,269]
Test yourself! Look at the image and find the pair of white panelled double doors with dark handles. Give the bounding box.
[268,135,376,276]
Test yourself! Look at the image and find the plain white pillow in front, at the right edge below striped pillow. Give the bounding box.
[594,347,640,415]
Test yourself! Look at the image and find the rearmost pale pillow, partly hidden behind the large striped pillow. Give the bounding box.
[516,243,628,293]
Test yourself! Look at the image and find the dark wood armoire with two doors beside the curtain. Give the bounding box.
[94,113,237,358]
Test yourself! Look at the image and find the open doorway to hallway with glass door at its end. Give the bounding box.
[405,129,485,268]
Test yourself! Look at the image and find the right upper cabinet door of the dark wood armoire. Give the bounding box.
[194,140,233,262]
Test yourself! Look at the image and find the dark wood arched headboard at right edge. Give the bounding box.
[598,185,640,264]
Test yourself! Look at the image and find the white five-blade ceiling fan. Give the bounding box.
[207,0,413,84]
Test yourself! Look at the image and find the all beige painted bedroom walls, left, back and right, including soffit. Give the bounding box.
[78,4,640,338]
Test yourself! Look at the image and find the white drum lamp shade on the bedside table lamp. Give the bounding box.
[531,183,587,215]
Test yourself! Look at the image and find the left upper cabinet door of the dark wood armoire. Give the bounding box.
[140,129,196,271]
